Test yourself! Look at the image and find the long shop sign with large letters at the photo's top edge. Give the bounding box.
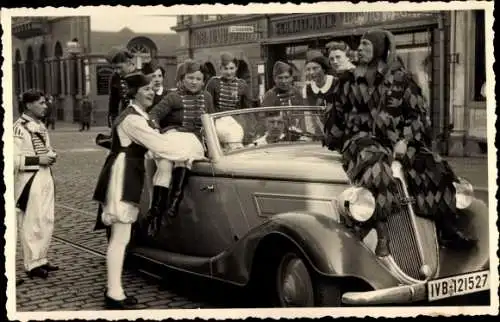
[271,11,437,37]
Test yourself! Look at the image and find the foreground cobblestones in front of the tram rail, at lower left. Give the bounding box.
[16,238,209,311]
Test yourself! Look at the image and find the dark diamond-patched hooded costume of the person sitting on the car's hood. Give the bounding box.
[325,31,472,253]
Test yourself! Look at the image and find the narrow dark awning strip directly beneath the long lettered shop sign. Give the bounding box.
[260,18,437,45]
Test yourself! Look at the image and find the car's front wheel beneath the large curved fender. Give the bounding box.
[276,252,342,307]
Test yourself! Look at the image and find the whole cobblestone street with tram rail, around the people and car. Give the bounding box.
[12,125,487,311]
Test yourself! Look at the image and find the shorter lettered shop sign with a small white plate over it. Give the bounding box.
[191,24,261,48]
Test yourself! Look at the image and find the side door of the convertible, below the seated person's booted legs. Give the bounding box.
[158,162,246,257]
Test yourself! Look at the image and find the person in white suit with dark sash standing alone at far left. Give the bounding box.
[14,90,59,278]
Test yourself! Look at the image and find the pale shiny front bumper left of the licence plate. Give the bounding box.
[342,283,427,306]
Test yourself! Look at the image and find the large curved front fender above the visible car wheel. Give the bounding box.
[212,211,400,289]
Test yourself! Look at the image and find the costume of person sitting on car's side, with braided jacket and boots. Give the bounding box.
[149,60,214,226]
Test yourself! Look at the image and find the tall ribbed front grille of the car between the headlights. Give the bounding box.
[386,179,438,280]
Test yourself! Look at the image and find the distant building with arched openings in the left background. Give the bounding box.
[12,16,179,125]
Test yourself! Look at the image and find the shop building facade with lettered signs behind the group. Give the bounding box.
[172,11,486,154]
